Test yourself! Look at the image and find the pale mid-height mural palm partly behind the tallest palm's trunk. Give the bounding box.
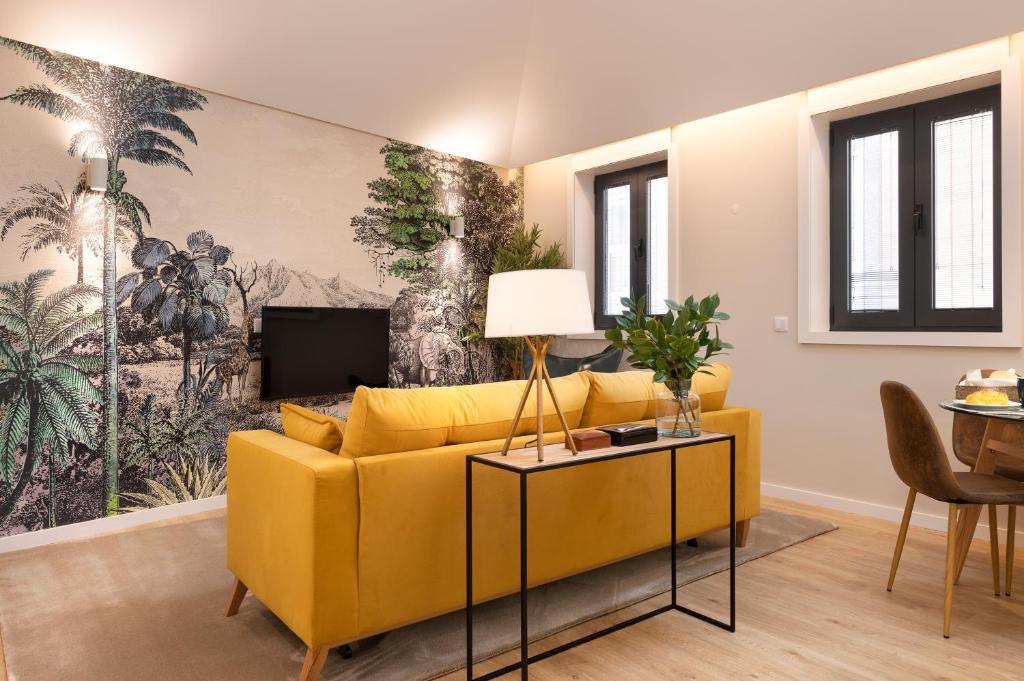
[0,176,150,284]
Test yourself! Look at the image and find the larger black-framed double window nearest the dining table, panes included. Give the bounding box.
[829,86,1002,332]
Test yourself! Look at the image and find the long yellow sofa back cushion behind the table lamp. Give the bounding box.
[342,373,590,457]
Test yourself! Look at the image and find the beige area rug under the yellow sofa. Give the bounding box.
[0,510,836,681]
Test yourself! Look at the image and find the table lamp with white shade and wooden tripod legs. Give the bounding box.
[483,269,594,461]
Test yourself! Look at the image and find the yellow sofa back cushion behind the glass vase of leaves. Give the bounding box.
[581,364,732,428]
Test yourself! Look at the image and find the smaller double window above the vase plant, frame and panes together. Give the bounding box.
[594,161,669,329]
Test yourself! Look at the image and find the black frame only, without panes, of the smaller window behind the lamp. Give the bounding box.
[594,161,669,329]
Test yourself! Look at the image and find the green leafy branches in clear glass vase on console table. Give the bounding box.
[604,294,732,437]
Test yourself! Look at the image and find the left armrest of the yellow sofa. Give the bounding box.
[227,430,358,647]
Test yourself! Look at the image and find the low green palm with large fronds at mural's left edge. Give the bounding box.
[0,269,102,526]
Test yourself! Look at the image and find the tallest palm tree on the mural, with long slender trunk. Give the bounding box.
[0,38,207,515]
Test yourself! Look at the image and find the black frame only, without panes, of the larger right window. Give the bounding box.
[829,85,1002,332]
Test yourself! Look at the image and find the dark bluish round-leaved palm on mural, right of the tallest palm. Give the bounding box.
[117,229,233,393]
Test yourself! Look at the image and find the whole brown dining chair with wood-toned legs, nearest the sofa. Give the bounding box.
[880,381,1024,638]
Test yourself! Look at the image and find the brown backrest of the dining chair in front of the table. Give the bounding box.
[880,381,963,502]
